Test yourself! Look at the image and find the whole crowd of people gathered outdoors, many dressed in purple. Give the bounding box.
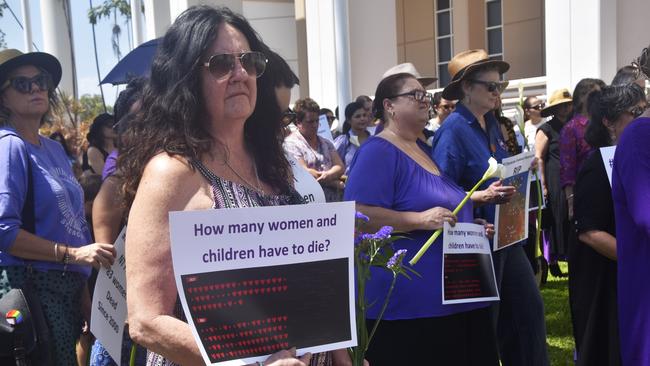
[0,6,650,366]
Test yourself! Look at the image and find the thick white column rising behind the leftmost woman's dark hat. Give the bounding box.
[40,0,77,98]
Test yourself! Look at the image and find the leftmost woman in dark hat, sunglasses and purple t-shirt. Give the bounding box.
[0,49,115,365]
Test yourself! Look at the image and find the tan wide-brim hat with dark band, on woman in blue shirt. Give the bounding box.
[442,49,510,100]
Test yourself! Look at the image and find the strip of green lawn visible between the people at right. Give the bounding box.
[542,263,575,366]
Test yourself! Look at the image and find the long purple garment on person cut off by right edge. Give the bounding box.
[612,118,650,366]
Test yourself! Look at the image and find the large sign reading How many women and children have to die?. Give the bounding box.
[169,202,357,365]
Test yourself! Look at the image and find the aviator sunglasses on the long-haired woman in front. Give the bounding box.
[203,51,268,79]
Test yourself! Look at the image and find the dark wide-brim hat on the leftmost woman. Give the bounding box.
[0,48,61,87]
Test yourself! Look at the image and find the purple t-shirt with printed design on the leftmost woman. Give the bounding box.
[0,127,90,275]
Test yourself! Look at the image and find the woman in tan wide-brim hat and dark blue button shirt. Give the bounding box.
[432,50,548,366]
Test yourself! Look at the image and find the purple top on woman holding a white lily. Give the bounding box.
[345,137,489,320]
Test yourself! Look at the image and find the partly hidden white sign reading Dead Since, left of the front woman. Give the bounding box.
[90,227,126,363]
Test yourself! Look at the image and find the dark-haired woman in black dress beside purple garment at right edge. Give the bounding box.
[569,83,647,365]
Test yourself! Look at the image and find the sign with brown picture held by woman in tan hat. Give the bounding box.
[494,151,535,250]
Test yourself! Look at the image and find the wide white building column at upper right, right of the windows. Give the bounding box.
[545,0,617,95]
